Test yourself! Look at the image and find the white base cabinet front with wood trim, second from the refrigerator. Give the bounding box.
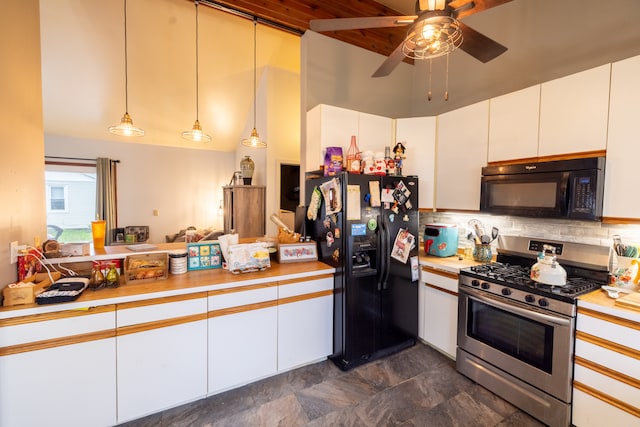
[208,283,278,394]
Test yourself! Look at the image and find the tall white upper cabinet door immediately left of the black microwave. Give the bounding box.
[436,101,489,211]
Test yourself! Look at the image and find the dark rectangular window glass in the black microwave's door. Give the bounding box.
[489,182,558,208]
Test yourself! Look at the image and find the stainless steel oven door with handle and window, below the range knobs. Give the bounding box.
[458,286,575,403]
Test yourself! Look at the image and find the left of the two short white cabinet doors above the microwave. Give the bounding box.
[488,85,540,162]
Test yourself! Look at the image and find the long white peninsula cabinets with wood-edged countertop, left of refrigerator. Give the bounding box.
[0,245,335,426]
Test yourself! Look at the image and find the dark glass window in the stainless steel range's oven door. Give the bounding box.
[467,298,553,374]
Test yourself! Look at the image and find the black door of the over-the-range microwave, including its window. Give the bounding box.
[480,172,570,218]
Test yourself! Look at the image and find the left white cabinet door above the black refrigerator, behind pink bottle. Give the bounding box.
[303,104,362,171]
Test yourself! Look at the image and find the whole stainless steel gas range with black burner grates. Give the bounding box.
[456,236,609,426]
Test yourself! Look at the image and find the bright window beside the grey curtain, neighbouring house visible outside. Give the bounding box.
[45,163,96,243]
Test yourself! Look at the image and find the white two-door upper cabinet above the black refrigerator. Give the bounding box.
[303,104,394,171]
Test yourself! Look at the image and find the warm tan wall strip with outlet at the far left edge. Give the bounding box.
[0,0,46,288]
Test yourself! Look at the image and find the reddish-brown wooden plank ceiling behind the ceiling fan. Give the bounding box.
[200,0,407,60]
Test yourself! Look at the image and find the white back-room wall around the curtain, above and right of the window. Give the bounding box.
[41,137,237,243]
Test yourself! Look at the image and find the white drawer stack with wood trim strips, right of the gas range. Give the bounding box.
[572,302,640,427]
